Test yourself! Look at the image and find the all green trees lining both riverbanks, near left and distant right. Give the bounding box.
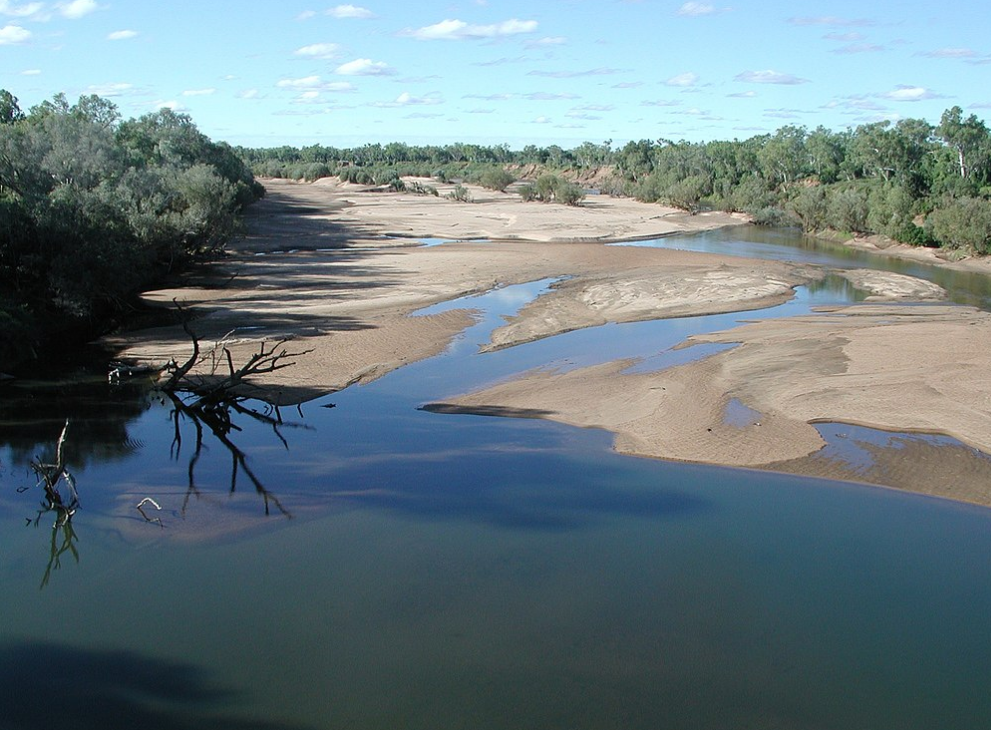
[0,89,991,371]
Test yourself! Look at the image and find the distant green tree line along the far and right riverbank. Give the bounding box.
[238,106,991,254]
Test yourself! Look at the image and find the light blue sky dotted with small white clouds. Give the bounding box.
[0,0,991,148]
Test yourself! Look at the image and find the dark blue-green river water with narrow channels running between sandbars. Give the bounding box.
[0,229,991,729]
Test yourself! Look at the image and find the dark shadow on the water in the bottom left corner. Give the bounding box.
[0,642,316,730]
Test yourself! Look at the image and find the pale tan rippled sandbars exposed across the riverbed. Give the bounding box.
[108,181,991,505]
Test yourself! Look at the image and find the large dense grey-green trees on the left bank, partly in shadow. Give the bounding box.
[0,90,264,370]
